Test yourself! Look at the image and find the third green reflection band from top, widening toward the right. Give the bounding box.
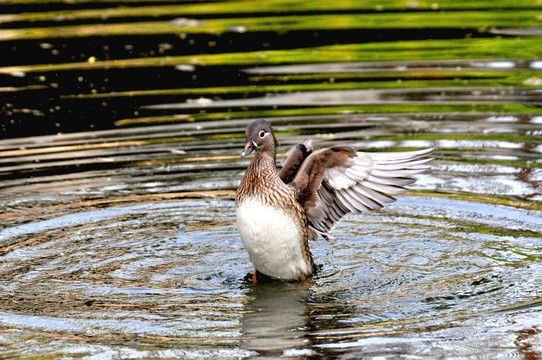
[4,37,542,74]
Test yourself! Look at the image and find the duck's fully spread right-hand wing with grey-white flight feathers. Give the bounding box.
[292,148,435,238]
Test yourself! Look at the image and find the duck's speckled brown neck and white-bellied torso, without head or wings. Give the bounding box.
[236,142,313,280]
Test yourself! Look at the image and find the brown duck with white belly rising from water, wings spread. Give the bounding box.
[235,119,436,282]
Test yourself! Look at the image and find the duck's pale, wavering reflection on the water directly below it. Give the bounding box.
[241,282,312,356]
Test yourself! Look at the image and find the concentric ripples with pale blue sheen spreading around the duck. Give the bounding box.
[0,196,542,357]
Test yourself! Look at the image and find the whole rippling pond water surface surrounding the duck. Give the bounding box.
[0,0,542,359]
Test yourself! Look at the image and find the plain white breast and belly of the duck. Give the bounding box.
[237,200,312,280]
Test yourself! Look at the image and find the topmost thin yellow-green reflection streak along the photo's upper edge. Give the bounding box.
[0,0,540,22]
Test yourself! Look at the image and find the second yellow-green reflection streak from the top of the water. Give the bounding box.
[0,9,540,40]
